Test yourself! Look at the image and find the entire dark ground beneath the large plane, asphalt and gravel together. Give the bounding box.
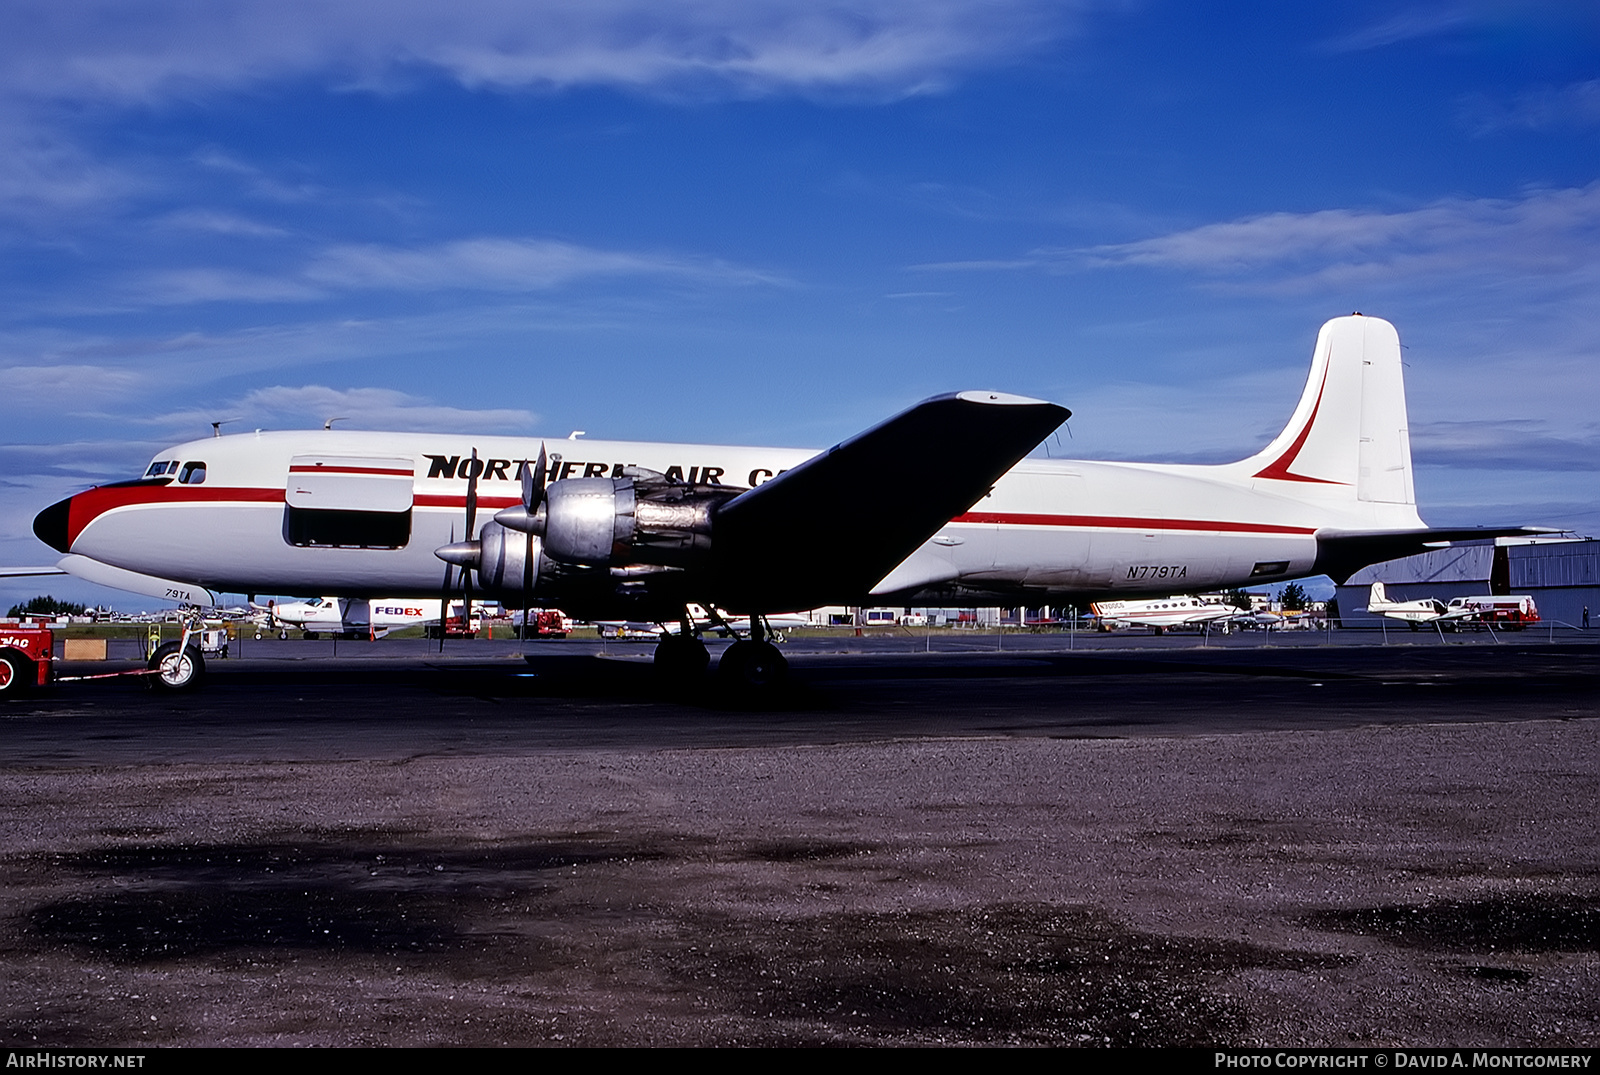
[0,632,1600,1046]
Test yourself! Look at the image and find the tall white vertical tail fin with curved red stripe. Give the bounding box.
[1238,314,1416,504]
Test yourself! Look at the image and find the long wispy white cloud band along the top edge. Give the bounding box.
[0,0,1090,102]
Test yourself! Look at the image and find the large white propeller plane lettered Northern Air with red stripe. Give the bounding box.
[21,315,1530,688]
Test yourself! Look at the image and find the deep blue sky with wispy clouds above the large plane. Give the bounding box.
[0,0,1600,608]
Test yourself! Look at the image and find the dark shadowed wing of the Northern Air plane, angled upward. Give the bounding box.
[712,392,1072,611]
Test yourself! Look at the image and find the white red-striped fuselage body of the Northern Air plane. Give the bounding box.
[56,430,1373,598]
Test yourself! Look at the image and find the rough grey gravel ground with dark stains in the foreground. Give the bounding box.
[0,710,1600,1046]
